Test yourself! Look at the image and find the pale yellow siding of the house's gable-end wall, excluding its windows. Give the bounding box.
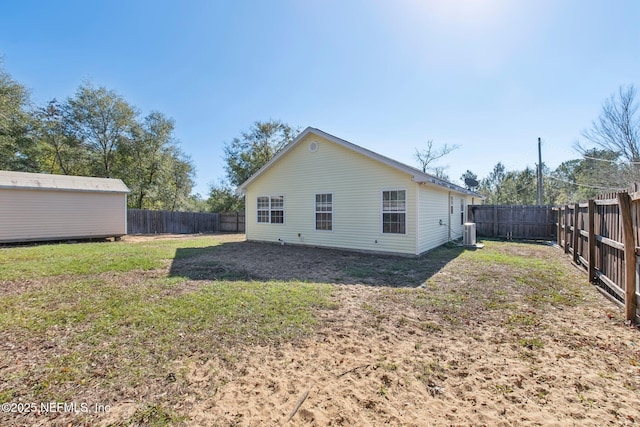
[245,134,417,254]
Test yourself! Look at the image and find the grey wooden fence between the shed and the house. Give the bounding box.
[127,209,244,234]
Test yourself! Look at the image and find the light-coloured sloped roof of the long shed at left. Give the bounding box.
[0,171,130,193]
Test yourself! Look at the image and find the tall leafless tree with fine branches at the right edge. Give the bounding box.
[578,85,640,162]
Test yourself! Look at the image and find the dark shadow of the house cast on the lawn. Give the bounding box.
[169,242,465,287]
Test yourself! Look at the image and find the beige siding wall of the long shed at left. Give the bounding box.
[0,189,127,242]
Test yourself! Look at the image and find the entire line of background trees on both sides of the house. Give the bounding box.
[5,54,640,212]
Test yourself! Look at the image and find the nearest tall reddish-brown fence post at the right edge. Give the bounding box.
[618,193,637,322]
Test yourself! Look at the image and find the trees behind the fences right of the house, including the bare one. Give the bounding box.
[462,85,640,205]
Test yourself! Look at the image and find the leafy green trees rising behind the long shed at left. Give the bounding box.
[0,64,198,210]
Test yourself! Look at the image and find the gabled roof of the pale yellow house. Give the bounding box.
[238,127,481,197]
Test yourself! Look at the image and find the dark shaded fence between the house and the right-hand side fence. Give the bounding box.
[468,205,556,240]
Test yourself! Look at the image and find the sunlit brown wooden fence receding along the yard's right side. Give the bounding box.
[555,192,640,321]
